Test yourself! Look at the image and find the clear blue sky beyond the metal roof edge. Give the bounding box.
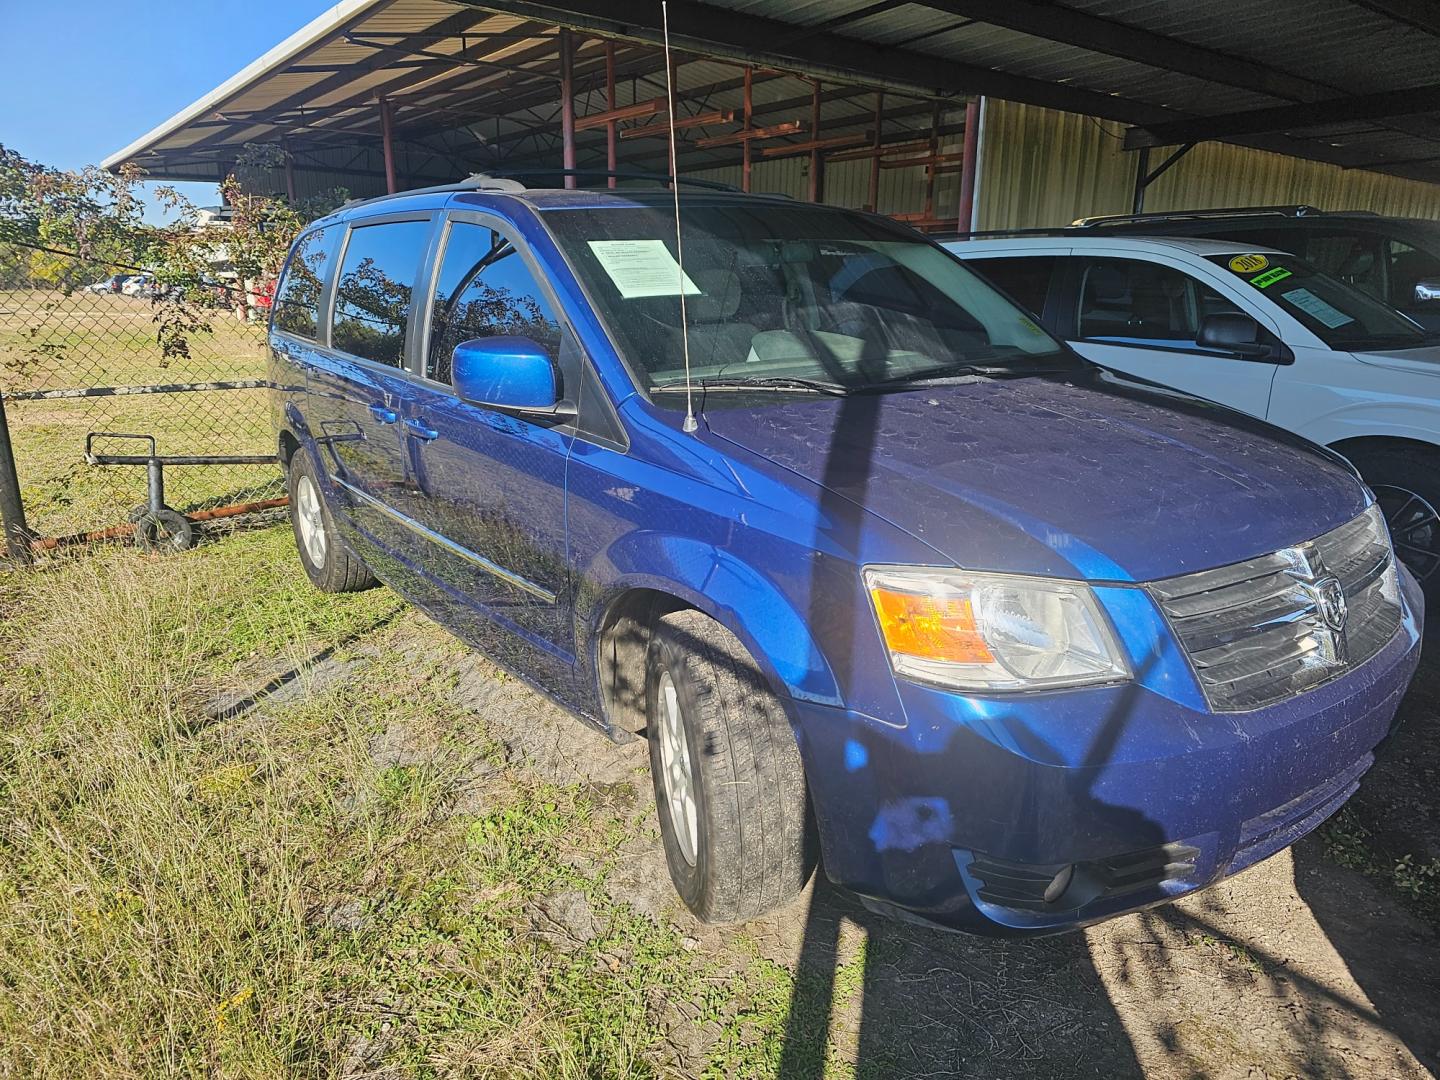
[0,0,331,220]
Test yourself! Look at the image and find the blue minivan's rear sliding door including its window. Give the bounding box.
[307,215,435,567]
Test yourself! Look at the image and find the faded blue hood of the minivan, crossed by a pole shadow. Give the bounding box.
[704,379,1367,580]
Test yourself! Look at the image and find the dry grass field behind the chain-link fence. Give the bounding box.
[0,289,279,536]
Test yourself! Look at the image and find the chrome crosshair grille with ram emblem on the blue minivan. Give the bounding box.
[1148,507,1401,713]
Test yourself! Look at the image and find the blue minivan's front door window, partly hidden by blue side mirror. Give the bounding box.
[425,222,562,383]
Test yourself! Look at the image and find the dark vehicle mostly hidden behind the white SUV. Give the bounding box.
[1077,206,1440,331]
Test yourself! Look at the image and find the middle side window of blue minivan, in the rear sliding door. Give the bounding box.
[330,220,431,367]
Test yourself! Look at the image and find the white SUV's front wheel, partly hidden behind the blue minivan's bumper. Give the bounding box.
[1351,446,1440,611]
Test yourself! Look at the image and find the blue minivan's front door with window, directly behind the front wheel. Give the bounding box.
[400,212,582,690]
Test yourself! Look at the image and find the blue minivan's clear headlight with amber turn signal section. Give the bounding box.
[865,566,1130,690]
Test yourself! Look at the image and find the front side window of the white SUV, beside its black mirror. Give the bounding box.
[1079,259,1238,348]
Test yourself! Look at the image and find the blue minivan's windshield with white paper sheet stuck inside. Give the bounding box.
[544,196,1081,392]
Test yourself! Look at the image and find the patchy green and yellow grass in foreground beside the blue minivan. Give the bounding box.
[0,527,829,1077]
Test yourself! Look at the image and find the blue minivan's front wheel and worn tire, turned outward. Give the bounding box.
[645,611,815,923]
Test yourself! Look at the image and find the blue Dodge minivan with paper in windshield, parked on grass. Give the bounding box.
[269,177,1423,933]
